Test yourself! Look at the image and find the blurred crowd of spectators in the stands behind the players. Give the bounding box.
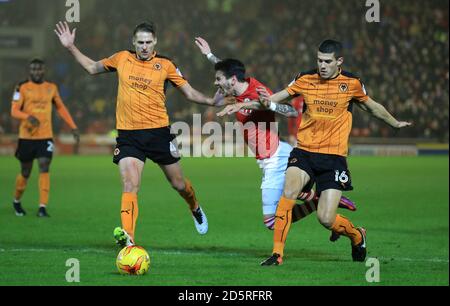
[0,0,449,142]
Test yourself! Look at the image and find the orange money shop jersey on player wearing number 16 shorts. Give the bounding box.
[286,70,369,156]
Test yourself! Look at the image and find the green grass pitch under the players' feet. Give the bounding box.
[0,156,449,286]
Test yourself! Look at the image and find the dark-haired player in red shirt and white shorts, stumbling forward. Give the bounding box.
[195,37,356,234]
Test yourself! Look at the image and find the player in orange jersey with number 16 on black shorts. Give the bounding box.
[255,40,411,265]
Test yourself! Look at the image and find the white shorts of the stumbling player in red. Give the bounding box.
[257,141,292,215]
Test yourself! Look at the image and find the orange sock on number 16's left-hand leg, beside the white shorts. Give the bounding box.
[273,197,295,256]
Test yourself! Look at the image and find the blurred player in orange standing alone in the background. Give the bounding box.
[11,59,80,217]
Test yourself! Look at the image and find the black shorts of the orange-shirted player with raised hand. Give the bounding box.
[113,127,180,165]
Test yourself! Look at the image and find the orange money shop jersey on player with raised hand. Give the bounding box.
[101,51,187,130]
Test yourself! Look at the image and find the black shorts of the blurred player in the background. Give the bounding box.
[15,138,55,162]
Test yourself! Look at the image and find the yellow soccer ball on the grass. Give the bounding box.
[116,245,150,275]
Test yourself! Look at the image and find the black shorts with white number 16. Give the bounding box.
[287,148,353,194]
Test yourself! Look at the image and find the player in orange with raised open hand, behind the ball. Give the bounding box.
[55,22,223,245]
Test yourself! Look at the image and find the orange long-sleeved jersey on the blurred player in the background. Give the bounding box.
[11,81,77,140]
